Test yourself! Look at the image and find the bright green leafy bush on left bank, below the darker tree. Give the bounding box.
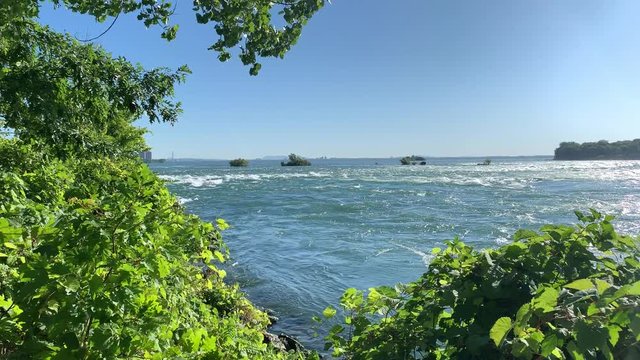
[0,139,310,359]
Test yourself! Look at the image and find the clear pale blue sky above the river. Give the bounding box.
[41,0,640,158]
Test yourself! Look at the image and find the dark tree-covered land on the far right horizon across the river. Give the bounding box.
[553,139,640,160]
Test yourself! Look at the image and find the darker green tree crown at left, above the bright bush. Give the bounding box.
[0,20,189,157]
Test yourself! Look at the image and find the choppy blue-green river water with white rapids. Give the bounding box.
[152,157,640,348]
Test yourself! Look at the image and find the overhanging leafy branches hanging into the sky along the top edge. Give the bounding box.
[0,0,325,75]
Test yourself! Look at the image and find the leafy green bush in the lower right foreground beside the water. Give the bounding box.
[324,211,640,359]
